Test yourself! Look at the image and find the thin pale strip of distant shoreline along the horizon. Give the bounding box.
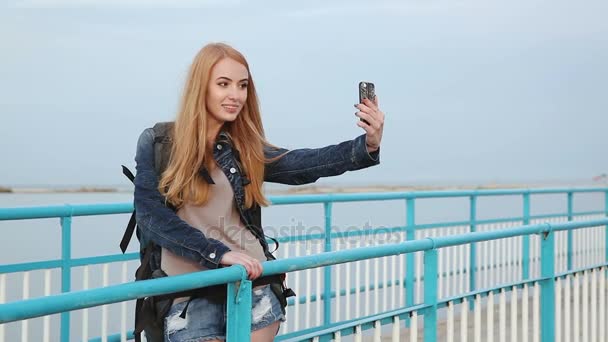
[0,182,608,195]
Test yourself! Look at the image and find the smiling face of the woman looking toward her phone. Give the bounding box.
[206,58,249,124]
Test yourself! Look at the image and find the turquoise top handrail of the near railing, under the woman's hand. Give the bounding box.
[0,219,608,323]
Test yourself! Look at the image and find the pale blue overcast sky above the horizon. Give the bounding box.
[0,0,608,186]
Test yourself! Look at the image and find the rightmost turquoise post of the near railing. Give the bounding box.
[540,224,555,342]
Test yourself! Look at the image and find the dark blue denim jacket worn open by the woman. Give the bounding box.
[134,128,380,269]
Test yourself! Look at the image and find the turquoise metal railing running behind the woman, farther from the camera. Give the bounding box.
[0,188,608,341]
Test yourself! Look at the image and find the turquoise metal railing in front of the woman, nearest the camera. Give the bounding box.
[0,219,608,341]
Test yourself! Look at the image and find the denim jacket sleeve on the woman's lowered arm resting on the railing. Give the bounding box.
[134,128,230,269]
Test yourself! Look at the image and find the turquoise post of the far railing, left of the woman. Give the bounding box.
[60,216,72,342]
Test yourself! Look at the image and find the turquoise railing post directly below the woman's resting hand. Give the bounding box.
[226,280,252,341]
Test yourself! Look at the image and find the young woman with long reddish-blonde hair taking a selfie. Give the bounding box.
[134,44,384,341]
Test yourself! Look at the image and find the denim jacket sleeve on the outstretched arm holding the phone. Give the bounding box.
[264,134,380,185]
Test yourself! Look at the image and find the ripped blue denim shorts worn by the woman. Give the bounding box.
[165,285,285,342]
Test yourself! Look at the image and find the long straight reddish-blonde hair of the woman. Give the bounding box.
[159,43,272,208]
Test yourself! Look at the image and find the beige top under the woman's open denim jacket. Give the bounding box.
[161,167,266,275]
